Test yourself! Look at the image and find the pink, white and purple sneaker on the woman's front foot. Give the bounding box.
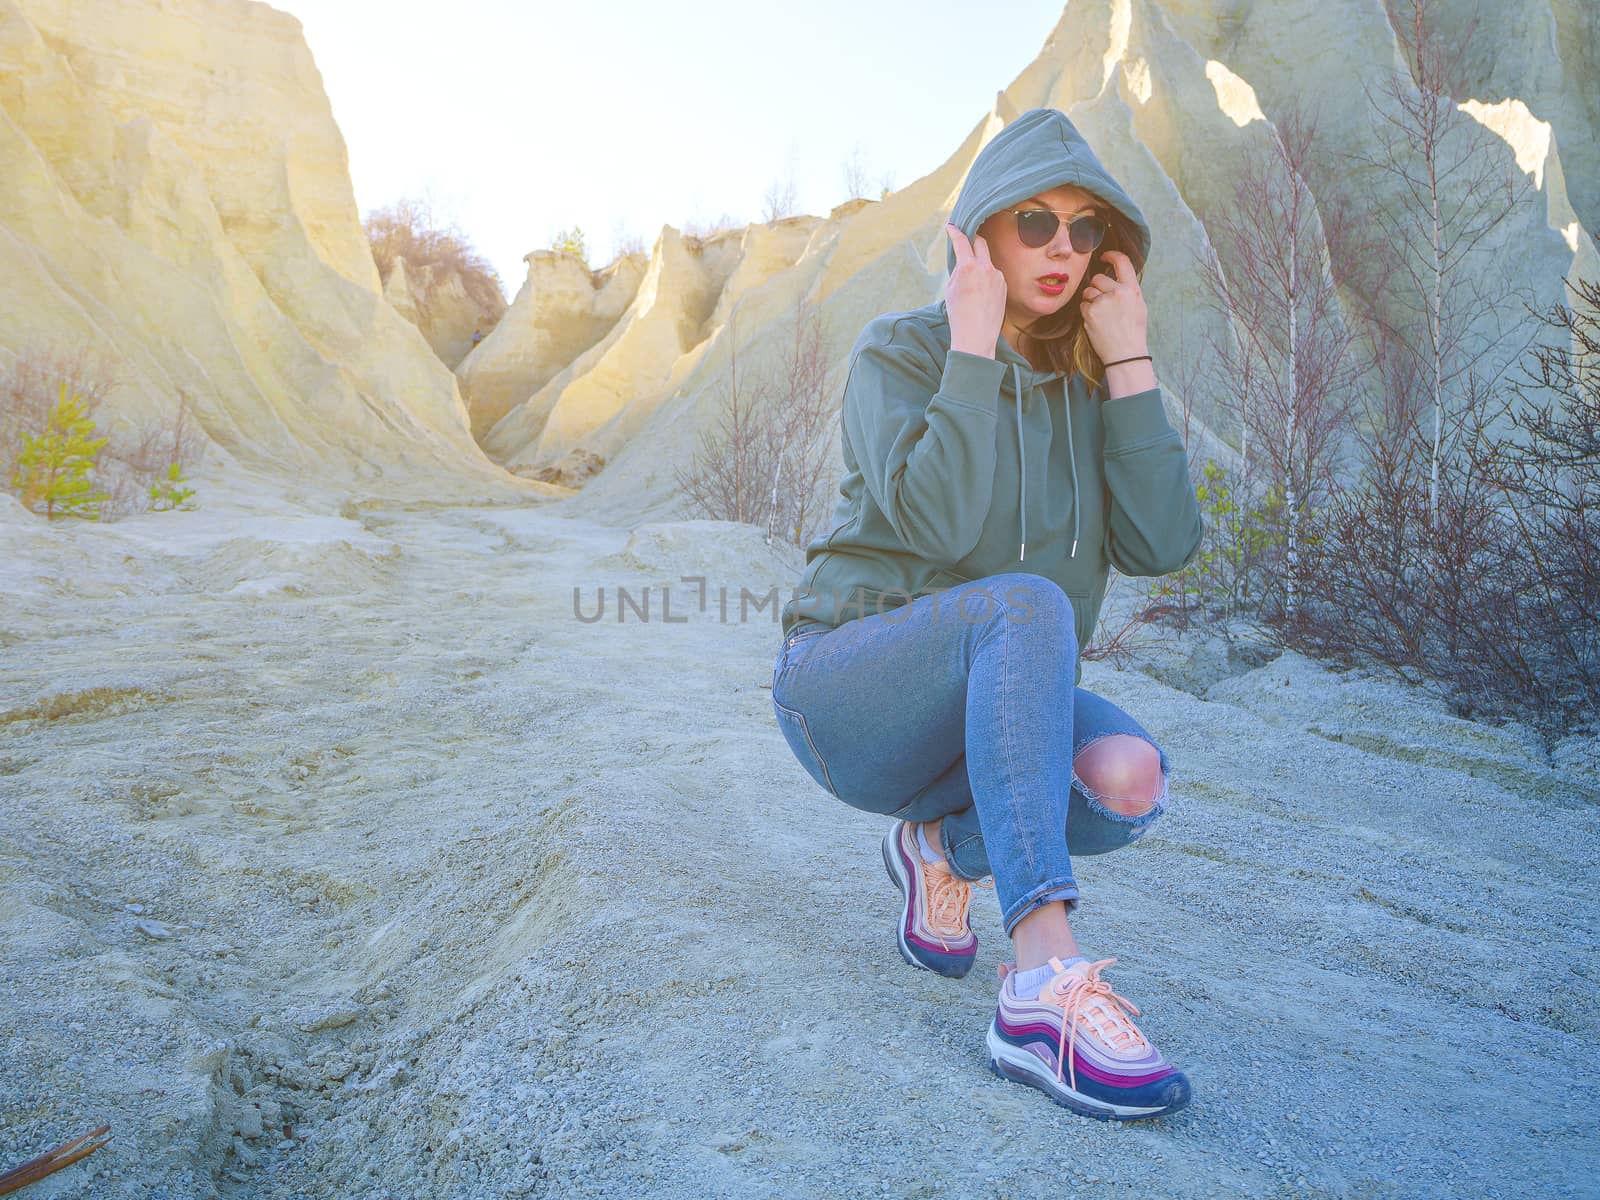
[986,958,1190,1122]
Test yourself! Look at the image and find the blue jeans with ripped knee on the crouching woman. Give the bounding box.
[773,573,1168,936]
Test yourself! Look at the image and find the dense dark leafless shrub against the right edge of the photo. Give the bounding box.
[1298,283,1600,736]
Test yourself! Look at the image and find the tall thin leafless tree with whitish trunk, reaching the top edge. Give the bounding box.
[1354,0,1525,522]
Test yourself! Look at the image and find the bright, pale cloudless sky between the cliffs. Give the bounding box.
[274,0,1066,299]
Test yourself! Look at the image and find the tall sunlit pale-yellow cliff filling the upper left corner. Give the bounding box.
[0,0,530,493]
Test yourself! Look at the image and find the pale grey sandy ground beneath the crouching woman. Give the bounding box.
[0,483,1600,1200]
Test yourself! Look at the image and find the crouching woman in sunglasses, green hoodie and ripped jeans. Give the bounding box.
[773,109,1200,1120]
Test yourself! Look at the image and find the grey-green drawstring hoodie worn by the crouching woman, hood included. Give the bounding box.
[782,109,1200,680]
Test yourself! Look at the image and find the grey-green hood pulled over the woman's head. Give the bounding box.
[944,109,1150,274]
